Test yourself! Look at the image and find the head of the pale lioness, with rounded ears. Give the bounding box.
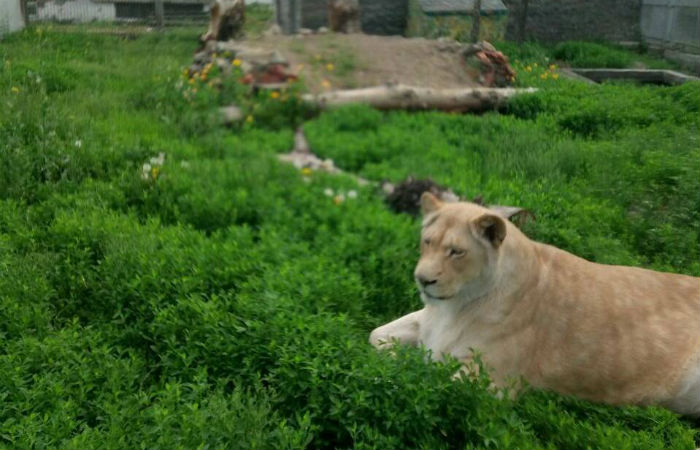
[414,192,507,303]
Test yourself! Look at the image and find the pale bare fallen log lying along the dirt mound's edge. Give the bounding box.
[302,84,537,112]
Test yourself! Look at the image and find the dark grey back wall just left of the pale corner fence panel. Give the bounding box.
[504,0,640,42]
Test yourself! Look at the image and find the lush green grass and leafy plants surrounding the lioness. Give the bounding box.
[0,22,700,449]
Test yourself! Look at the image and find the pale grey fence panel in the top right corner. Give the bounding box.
[640,0,700,54]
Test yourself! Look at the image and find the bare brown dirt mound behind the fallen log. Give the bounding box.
[243,33,478,93]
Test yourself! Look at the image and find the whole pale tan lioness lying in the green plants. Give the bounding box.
[370,193,700,415]
